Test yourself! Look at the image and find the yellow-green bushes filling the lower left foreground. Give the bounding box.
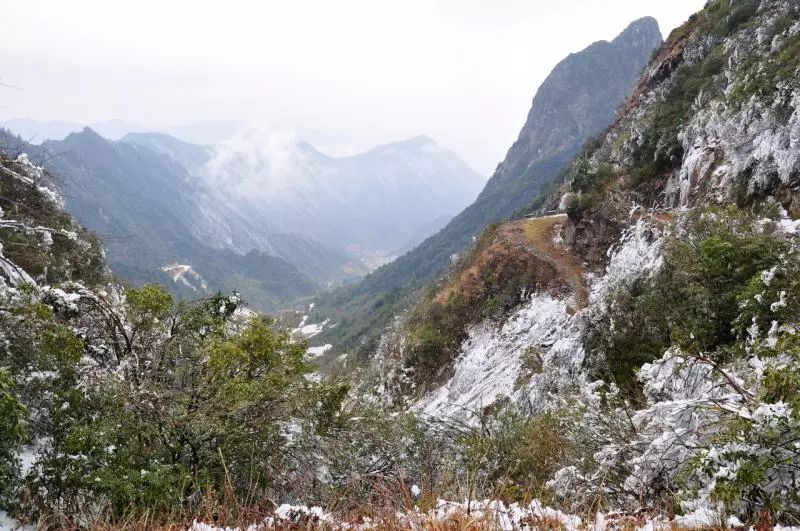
[3,285,347,517]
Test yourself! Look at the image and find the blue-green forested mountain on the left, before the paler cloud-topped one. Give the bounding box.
[4,128,340,309]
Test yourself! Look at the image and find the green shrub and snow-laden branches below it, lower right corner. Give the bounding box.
[550,209,800,523]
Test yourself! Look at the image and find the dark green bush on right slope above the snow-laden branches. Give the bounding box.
[588,207,787,394]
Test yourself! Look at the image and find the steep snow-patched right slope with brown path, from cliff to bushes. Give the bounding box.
[373,0,800,528]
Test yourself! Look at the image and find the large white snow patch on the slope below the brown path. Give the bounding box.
[413,215,662,419]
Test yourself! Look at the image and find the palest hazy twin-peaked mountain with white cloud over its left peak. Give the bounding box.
[200,130,483,254]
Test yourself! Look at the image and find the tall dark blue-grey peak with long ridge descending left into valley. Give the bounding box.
[318,18,661,358]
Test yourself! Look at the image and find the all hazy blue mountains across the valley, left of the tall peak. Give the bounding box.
[0,128,481,310]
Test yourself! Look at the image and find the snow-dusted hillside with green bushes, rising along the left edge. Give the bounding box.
[0,150,360,529]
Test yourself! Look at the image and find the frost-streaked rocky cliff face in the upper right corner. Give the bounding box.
[550,1,800,262]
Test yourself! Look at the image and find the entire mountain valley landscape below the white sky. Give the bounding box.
[0,0,800,531]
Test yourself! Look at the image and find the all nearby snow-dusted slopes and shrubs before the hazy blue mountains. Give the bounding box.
[0,0,800,531]
